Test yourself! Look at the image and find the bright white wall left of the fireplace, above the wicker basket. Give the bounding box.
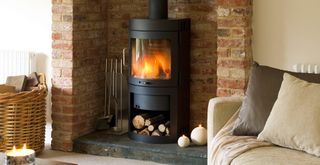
[0,0,52,119]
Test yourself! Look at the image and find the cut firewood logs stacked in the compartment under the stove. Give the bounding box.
[132,113,170,136]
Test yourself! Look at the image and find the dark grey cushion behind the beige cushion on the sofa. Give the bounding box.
[233,63,320,136]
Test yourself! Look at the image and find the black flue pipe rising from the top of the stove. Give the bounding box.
[149,0,168,19]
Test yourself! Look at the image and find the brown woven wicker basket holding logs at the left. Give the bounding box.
[0,74,47,153]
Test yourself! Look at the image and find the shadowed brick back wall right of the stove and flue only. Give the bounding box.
[169,0,217,129]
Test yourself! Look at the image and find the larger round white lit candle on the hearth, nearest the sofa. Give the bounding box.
[191,124,207,145]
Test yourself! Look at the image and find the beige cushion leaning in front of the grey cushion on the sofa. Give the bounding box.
[258,73,320,156]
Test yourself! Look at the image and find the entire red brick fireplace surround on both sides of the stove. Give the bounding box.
[52,0,252,151]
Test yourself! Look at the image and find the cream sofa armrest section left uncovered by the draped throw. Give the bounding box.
[207,97,242,142]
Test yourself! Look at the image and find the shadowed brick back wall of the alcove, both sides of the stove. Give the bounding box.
[108,0,217,130]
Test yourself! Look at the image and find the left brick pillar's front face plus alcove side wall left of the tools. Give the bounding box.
[52,0,107,151]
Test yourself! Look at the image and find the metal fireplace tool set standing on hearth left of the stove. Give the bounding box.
[96,49,128,135]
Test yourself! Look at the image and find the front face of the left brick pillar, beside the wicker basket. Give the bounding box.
[51,0,75,150]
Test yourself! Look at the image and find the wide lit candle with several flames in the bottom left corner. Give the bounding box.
[5,144,35,165]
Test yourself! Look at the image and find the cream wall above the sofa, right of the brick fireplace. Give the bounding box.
[253,0,320,70]
